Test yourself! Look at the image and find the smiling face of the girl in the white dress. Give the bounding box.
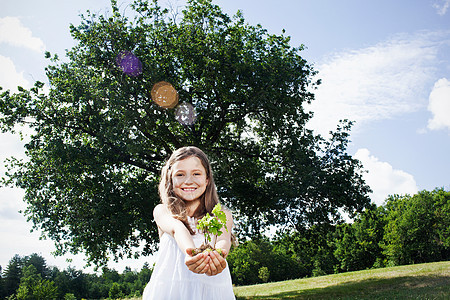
[172,156,208,205]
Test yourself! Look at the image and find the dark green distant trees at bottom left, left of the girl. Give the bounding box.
[0,254,152,300]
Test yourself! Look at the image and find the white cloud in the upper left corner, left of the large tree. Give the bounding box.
[0,17,45,52]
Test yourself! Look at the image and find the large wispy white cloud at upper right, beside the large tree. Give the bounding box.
[309,33,440,134]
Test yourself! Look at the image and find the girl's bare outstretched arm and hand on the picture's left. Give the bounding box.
[153,204,210,274]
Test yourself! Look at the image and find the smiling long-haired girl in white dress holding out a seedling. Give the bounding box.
[142,147,235,300]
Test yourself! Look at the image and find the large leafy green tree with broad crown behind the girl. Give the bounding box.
[0,0,369,263]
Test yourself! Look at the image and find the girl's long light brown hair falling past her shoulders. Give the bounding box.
[159,146,219,234]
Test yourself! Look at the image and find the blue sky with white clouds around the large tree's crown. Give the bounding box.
[0,0,450,271]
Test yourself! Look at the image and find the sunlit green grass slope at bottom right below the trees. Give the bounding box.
[234,261,450,299]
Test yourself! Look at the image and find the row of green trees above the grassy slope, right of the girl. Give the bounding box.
[227,189,450,285]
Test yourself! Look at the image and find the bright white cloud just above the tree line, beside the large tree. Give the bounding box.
[354,148,418,205]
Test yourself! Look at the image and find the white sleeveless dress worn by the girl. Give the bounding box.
[142,217,236,300]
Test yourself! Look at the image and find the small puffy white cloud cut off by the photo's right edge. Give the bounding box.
[428,78,450,130]
